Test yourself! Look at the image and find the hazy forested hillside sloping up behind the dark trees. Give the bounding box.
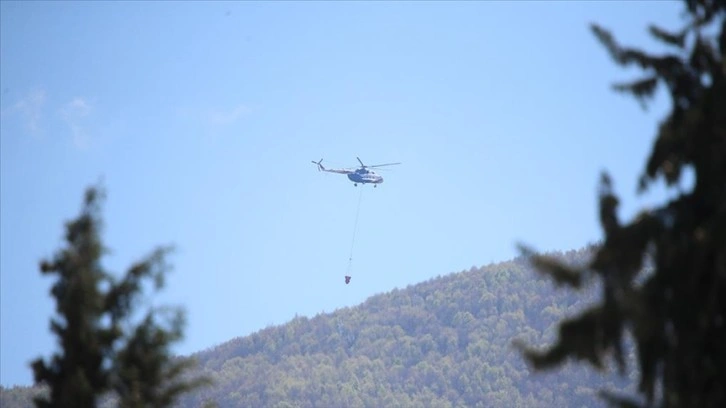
[0,245,644,408]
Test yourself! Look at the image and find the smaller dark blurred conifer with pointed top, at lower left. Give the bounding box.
[32,188,206,407]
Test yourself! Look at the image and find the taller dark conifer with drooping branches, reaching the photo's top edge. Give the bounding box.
[519,0,726,407]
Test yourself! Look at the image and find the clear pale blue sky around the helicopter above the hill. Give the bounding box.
[0,1,681,386]
